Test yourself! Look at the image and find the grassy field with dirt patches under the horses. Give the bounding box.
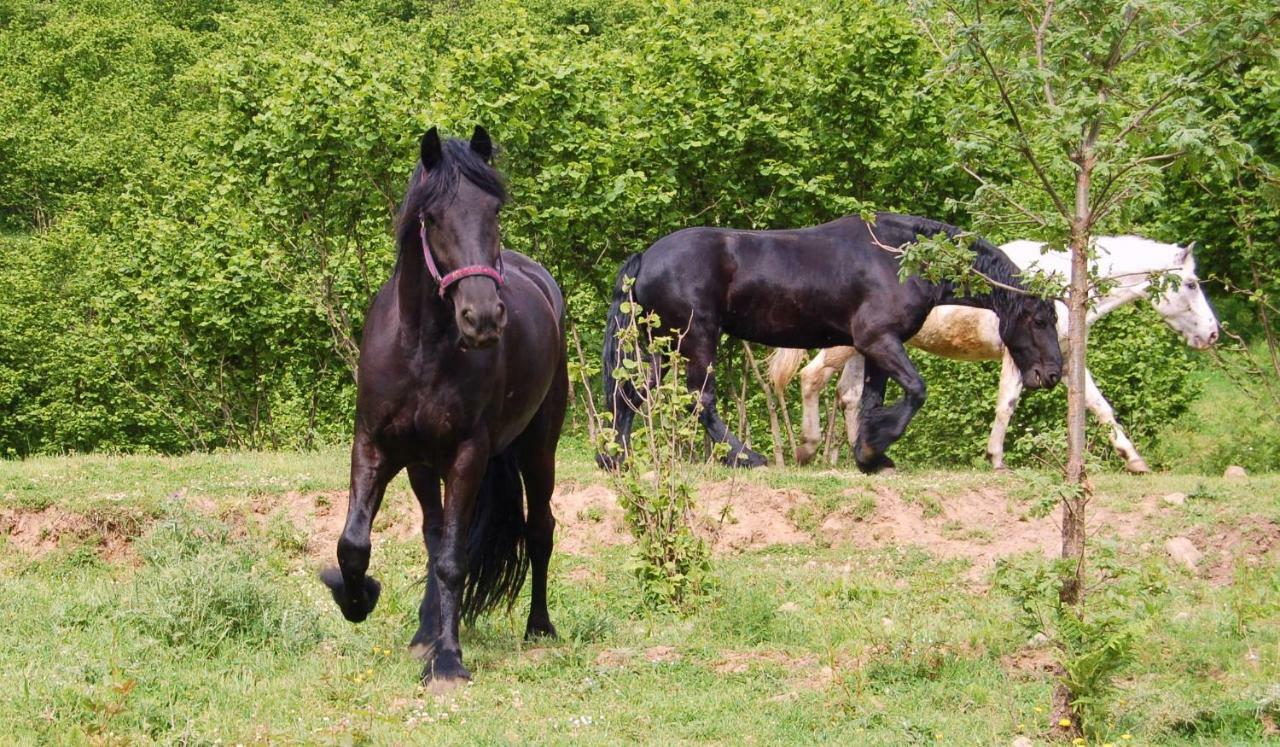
[0,444,1280,744]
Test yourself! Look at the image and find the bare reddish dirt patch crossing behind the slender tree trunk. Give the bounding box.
[820,485,1142,581]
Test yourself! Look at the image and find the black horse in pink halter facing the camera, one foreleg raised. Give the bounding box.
[321,128,568,682]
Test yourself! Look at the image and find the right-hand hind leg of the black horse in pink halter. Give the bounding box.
[520,353,568,638]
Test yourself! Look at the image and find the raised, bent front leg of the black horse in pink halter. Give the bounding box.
[320,431,398,623]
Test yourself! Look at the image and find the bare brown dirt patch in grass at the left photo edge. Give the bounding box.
[0,505,143,563]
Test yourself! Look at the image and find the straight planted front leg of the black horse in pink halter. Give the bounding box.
[422,435,489,684]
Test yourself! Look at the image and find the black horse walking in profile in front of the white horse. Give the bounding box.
[598,214,1062,472]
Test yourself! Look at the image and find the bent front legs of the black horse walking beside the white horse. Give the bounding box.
[854,335,925,472]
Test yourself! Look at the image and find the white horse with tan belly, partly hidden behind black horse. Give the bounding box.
[769,235,1219,472]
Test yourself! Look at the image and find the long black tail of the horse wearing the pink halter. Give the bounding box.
[462,446,529,624]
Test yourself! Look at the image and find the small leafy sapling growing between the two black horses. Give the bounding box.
[595,279,727,610]
